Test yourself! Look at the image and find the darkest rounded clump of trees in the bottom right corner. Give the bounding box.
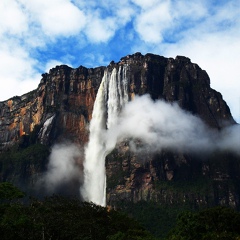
[167,207,240,240]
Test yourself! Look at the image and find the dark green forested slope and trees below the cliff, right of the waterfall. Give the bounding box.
[117,201,240,240]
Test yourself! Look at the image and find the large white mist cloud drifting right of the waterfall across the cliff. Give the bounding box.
[103,95,240,157]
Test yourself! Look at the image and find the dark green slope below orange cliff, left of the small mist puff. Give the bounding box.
[0,125,50,183]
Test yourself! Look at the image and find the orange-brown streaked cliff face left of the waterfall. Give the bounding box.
[0,65,103,149]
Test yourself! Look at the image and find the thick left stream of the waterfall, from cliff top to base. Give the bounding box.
[81,74,107,206]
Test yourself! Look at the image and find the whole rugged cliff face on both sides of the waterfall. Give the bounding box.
[0,53,237,206]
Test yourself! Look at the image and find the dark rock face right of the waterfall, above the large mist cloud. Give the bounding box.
[122,54,234,128]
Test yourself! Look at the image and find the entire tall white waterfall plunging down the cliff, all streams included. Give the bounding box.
[81,65,128,206]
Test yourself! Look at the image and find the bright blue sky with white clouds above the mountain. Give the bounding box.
[0,0,240,122]
